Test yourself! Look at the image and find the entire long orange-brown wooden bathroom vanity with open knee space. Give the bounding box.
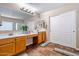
[0,31,46,56]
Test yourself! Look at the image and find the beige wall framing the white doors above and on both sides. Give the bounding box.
[41,4,79,48]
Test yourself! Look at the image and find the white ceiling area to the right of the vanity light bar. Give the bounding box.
[29,3,66,13]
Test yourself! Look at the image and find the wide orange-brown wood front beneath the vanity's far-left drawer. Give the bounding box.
[0,43,15,56]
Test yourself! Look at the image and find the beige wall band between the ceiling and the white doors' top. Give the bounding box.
[41,4,79,17]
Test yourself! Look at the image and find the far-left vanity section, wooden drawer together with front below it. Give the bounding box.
[0,38,15,56]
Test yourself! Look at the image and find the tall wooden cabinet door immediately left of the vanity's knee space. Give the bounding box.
[16,37,26,53]
